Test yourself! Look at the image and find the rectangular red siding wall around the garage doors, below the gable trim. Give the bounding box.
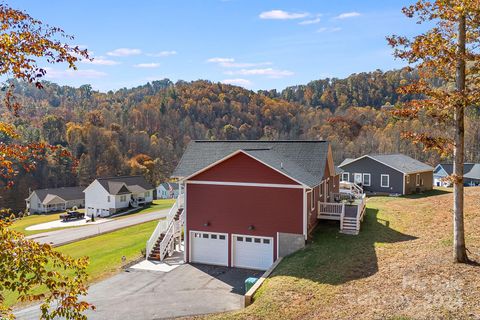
[186,184,303,264]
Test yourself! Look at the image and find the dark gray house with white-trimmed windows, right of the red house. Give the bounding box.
[339,154,433,195]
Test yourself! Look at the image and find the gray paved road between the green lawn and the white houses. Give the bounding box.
[27,209,170,246]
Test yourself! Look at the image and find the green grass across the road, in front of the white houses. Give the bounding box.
[12,199,175,236]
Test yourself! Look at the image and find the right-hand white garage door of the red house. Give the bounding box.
[232,235,273,270]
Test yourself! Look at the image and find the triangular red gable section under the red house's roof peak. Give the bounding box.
[191,153,298,184]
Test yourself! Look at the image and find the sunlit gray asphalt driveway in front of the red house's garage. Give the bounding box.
[15,264,262,320]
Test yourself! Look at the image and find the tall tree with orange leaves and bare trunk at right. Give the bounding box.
[387,0,480,263]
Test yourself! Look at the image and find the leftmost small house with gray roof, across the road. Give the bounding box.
[25,187,85,214]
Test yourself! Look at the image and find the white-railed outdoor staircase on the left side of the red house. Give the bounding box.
[146,195,185,261]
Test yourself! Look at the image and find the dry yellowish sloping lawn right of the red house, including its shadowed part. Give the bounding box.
[206,188,480,319]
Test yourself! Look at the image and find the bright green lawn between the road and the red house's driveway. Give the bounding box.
[5,221,157,305]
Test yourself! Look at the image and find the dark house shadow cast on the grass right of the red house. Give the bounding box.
[274,208,417,285]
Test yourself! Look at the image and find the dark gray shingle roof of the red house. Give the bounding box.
[172,141,328,187]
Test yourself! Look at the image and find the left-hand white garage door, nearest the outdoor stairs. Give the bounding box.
[190,231,228,266]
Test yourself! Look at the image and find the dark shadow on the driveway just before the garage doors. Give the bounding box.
[190,263,265,295]
